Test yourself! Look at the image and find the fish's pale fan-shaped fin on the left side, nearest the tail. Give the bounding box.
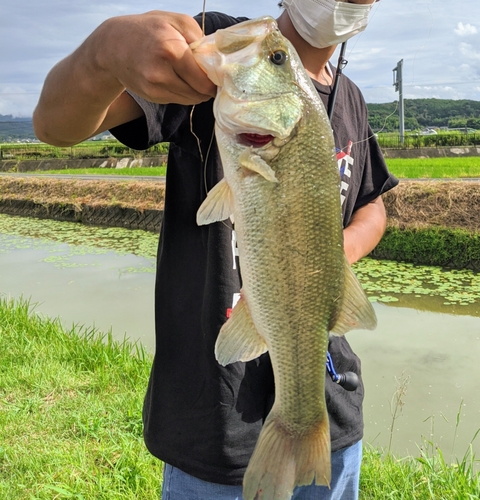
[215,297,267,366]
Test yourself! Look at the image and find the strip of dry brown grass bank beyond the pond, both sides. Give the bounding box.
[0,177,480,231]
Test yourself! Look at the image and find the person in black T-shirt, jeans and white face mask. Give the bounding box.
[33,0,397,500]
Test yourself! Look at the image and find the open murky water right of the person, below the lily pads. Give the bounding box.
[348,304,480,460]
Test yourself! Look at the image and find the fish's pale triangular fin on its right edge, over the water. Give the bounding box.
[330,259,377,335]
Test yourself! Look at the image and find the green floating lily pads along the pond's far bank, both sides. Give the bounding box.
[0,214,480,316]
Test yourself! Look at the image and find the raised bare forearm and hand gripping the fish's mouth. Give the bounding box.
[33,11,216,146]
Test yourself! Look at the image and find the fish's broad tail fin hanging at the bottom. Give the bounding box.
[243,410,331,500]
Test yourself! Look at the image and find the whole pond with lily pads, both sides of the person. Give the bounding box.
[0,215,480,460]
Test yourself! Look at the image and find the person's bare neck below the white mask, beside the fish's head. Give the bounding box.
[277,10,336,85]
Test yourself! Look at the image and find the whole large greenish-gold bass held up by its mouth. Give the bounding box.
[191,16,376,500]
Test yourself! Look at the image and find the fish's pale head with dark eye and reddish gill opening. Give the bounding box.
[191,16,316,150]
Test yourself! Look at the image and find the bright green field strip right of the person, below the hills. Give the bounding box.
[386,156,480,179]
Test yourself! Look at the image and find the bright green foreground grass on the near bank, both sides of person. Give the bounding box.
[0,298,480,500]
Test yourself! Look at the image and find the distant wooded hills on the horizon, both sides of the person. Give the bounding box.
[0,99,480,142]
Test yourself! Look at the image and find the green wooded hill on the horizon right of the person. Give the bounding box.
[367,99,480,132]
